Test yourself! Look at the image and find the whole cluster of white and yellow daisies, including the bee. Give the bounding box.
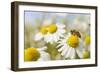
[24,19,90,61]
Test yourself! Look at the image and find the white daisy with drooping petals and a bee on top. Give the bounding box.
[57,30,84,59]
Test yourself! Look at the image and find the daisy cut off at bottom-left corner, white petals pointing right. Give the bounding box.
[24,47,50,62]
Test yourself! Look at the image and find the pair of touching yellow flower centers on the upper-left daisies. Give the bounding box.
[40,24,57,34]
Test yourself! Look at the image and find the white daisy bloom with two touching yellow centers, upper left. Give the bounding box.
[35,23,65,43]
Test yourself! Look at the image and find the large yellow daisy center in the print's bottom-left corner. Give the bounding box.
[24,48,40,61]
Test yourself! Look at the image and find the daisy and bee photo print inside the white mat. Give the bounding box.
[24,12,92,62]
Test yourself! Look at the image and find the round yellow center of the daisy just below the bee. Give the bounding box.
[67,35,79,48]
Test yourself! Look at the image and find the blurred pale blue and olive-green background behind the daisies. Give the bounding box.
[24,11,90,60]
